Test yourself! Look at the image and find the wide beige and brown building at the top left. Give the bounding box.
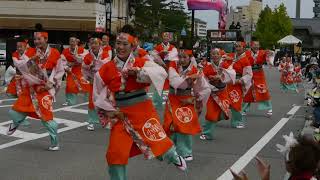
[0,0,128,43]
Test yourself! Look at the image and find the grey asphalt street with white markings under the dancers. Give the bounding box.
[0,68,304,180]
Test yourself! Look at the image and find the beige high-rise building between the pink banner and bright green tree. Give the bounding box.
[227,0,263,40]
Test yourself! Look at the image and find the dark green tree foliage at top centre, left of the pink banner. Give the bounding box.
[133,0,190,40]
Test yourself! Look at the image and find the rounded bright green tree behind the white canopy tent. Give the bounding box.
[255,4,292,48]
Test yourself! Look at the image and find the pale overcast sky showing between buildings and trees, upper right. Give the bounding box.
[185,0,314,29]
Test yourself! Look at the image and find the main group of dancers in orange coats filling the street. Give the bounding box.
[3,25,272,180]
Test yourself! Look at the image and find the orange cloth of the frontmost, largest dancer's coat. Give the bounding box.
[95,55,173,165]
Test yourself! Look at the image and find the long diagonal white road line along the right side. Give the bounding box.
[217,106,300,180]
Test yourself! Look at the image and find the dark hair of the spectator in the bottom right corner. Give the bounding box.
[289,137,320,175]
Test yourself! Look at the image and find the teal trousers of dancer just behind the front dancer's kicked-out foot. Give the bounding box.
[171,133,192,157]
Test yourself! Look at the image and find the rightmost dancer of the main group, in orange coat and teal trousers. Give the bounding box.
[242,40,272,116]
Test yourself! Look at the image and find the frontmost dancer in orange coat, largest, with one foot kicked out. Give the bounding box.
[94,27,186,180]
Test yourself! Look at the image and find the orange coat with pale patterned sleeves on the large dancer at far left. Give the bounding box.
[12,46,64,121]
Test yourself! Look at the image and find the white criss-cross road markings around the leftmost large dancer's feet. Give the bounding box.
[0,103,88,150]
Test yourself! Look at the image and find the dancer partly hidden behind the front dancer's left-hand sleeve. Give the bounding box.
[82,38,111,131]
